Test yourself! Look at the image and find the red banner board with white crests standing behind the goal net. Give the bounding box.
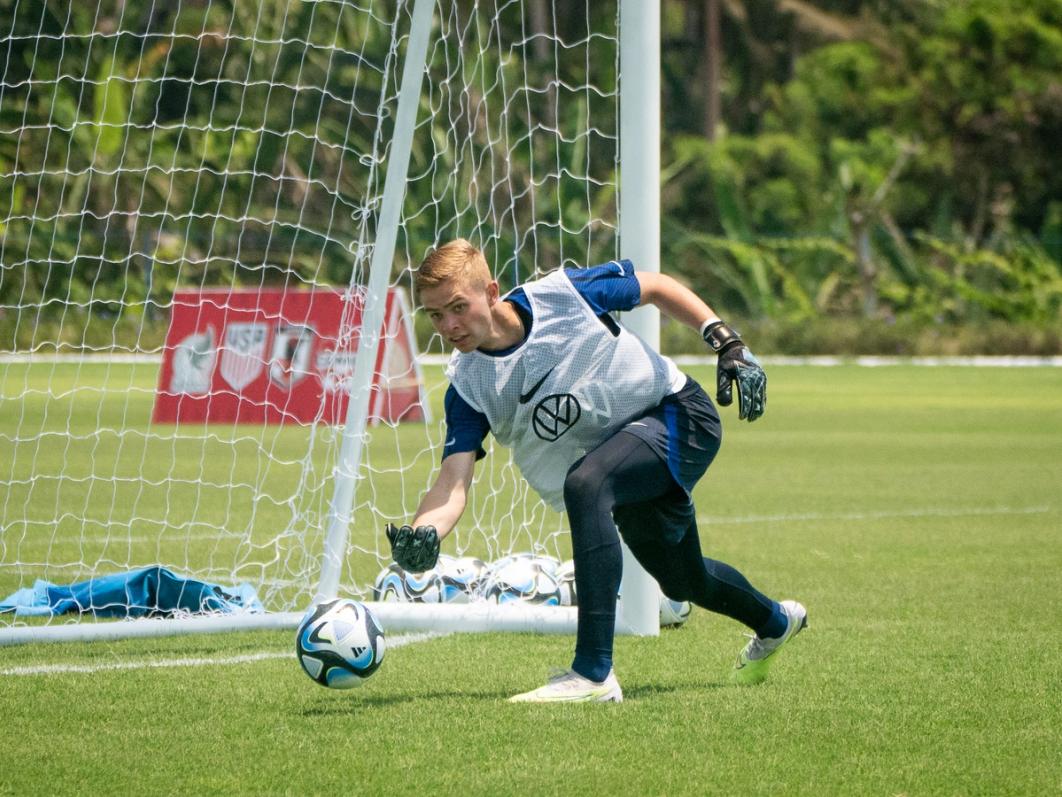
[152,288,427,424]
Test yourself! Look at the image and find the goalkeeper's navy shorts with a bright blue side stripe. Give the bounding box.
[613,378,722,544]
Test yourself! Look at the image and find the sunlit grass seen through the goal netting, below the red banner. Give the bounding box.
[0,359,567,611]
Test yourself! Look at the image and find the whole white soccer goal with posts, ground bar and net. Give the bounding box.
[0,0,660,644]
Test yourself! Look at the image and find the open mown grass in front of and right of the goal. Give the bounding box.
[0,367,1062,795]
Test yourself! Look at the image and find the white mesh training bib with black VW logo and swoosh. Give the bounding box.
[446,270,686,511]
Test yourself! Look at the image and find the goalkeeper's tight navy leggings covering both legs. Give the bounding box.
[564,431,775,681]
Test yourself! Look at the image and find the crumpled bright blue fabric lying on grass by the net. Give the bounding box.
[0,565,264,617]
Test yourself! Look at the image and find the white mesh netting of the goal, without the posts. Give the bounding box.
[0,0,618,617]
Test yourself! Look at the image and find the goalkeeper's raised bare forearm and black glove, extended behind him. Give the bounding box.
[635,271,767,422]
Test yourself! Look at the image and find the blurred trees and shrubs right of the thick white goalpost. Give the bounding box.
[665,0,1062,353]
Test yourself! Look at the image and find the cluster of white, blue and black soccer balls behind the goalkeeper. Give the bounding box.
[373,554,689,626]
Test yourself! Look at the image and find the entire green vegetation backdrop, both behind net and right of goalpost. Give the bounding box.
[0,0,1062,354]
